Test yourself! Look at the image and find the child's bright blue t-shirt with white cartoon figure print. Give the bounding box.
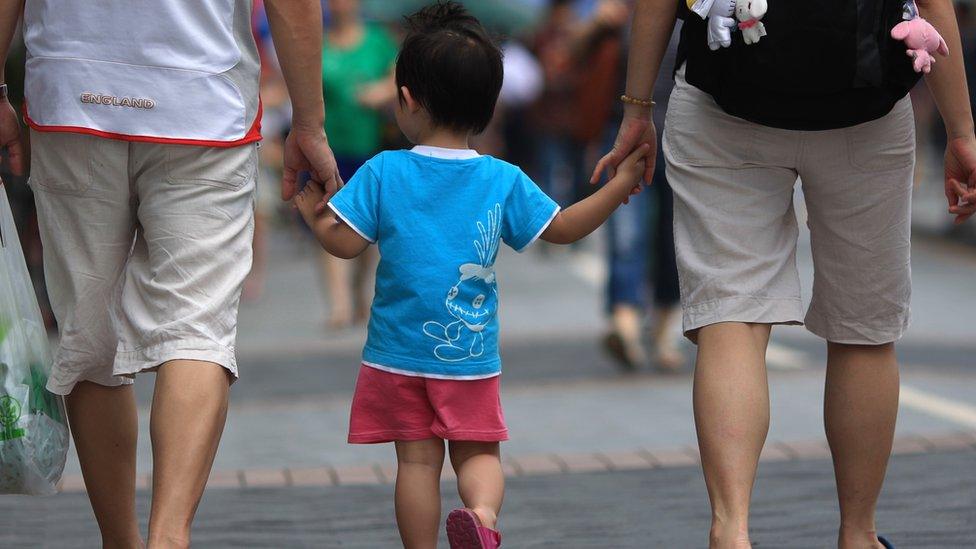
[329,147,559,379]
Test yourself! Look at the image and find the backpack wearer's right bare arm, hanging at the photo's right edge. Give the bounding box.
[917,0,976,223]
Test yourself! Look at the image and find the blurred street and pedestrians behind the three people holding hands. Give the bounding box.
[0,0,976,548]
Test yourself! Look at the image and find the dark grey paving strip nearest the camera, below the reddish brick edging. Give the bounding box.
[0,448,976,549]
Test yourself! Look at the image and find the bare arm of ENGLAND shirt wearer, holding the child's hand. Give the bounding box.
[264,0,341,200]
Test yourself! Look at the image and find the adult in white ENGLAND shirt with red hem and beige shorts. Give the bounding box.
[0,0,338,547]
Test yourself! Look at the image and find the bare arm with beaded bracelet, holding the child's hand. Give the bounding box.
[590,0,678,183]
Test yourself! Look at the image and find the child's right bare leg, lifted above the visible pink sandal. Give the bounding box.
[450,440,505,529]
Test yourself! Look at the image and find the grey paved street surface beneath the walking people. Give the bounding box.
[9,228,976,549]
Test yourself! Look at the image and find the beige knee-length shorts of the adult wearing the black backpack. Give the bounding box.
[663,68,915,345]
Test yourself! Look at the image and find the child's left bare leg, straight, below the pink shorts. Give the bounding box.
[396,438,444,549]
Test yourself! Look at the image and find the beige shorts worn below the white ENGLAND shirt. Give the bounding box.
[30,131,257,394]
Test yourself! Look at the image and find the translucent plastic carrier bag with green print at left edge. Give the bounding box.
[0,183,68,495]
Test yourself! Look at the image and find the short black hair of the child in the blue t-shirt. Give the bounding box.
[396,2,504,134]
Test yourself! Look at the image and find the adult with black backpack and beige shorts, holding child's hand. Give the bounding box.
[594,0,976,548]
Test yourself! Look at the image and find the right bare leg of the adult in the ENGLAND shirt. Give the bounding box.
[149,360,230,549]
